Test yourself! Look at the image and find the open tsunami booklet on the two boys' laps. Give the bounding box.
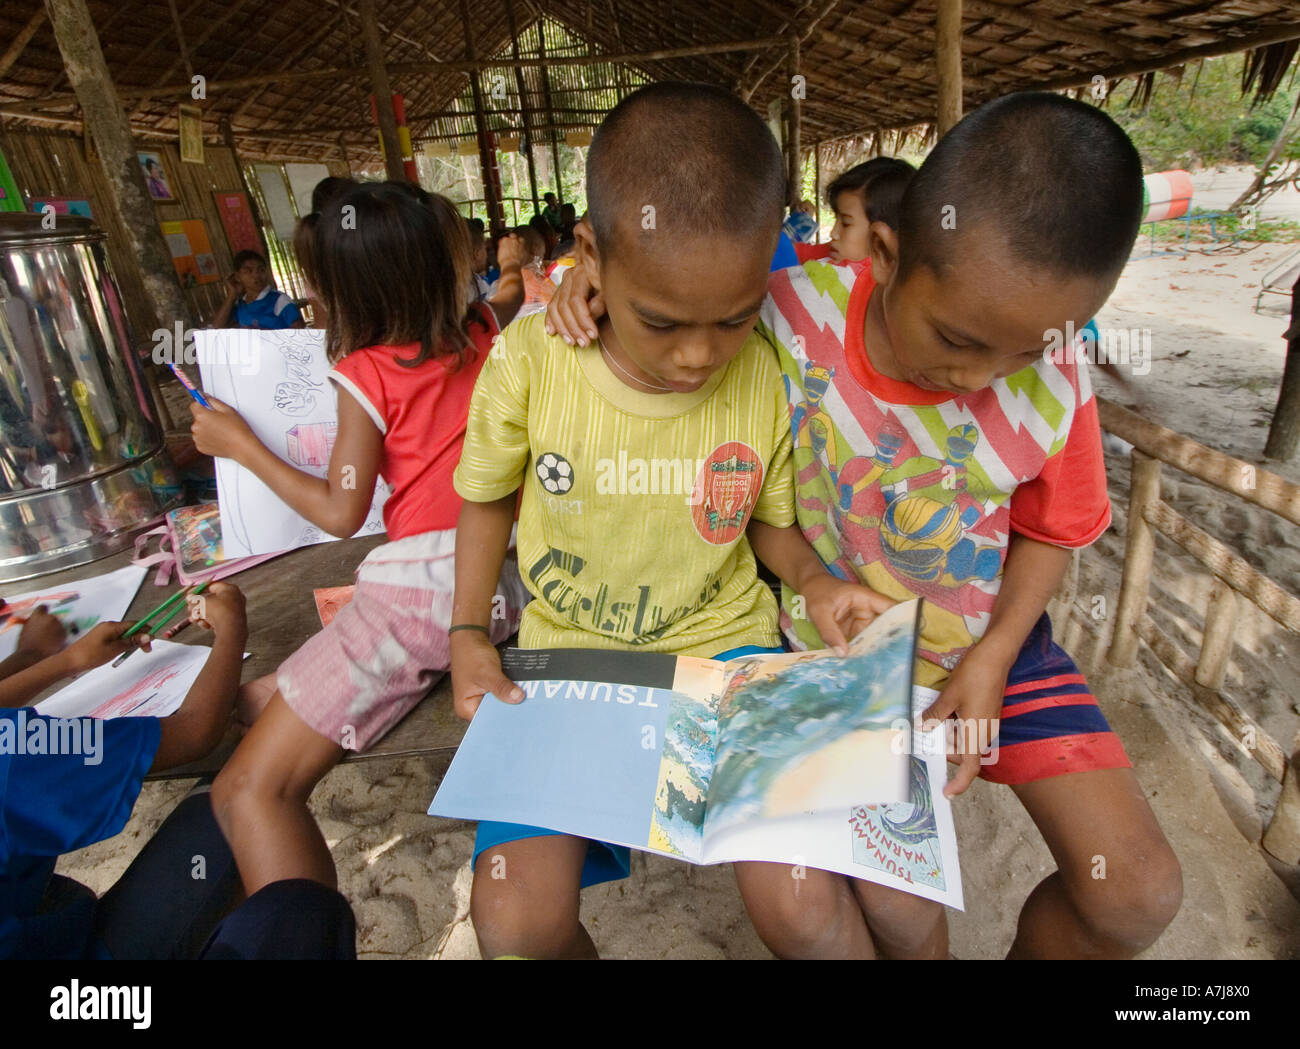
[429,601,962,907]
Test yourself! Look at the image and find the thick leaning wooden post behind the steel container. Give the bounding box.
[46,0,194,335]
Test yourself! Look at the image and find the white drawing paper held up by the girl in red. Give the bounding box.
[194,328,387,558]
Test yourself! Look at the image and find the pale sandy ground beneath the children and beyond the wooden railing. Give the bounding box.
[50,227,1300,958]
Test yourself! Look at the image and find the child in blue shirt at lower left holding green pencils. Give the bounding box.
[0,582,355,959]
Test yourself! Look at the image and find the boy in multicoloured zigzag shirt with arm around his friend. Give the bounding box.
[550,92,1182,958]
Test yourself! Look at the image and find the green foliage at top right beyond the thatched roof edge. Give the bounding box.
[1108,55,1300,172]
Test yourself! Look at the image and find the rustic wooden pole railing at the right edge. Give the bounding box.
[1097,398,1300,863]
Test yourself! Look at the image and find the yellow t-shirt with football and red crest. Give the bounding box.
[455,315,794,656]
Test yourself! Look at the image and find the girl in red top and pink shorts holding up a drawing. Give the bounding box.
[194,182,527,894]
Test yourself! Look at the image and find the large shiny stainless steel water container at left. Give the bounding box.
[0,213,181,581]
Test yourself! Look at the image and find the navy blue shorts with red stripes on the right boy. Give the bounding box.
[980,614,1132,784]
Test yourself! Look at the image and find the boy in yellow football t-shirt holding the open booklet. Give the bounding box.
[451,83,893,957]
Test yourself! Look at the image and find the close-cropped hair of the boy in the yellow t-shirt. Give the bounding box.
[586,82,785,253]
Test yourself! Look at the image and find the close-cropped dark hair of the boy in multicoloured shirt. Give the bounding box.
[898,91,1143,279]
